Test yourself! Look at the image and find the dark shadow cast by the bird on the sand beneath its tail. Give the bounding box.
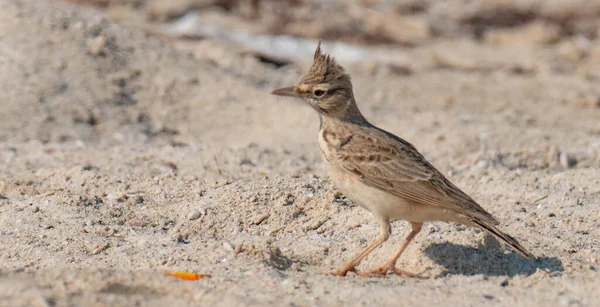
[425,242,564,277]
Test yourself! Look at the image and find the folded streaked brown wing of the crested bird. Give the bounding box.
[335,129,498,224]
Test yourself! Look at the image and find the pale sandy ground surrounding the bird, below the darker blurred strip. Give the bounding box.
[0,0,600,306]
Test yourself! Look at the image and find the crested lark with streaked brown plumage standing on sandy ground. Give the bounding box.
[272,42,533,276]
